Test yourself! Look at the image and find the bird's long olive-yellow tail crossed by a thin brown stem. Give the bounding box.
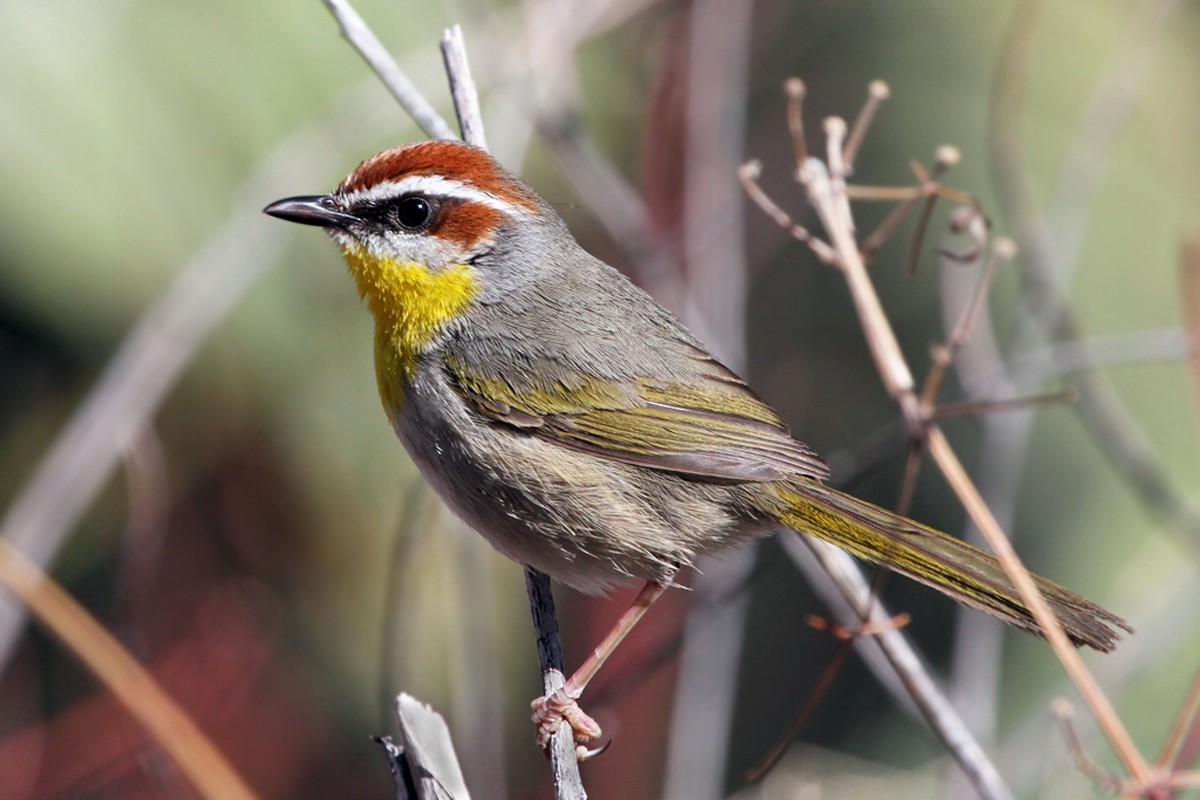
[776,480,1133,652]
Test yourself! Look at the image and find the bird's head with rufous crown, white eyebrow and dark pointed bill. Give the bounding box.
[264,142,559,319]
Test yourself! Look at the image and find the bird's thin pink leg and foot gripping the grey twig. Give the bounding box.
[532,581,670,750]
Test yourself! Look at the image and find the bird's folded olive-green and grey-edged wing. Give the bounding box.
[446,350,829,481]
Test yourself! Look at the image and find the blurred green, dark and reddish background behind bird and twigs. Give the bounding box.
[0,0,1200,798]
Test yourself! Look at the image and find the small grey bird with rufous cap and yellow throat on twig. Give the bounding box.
[265,140,1130,747]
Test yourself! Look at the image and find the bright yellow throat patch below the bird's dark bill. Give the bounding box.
[343,245,479,417]
